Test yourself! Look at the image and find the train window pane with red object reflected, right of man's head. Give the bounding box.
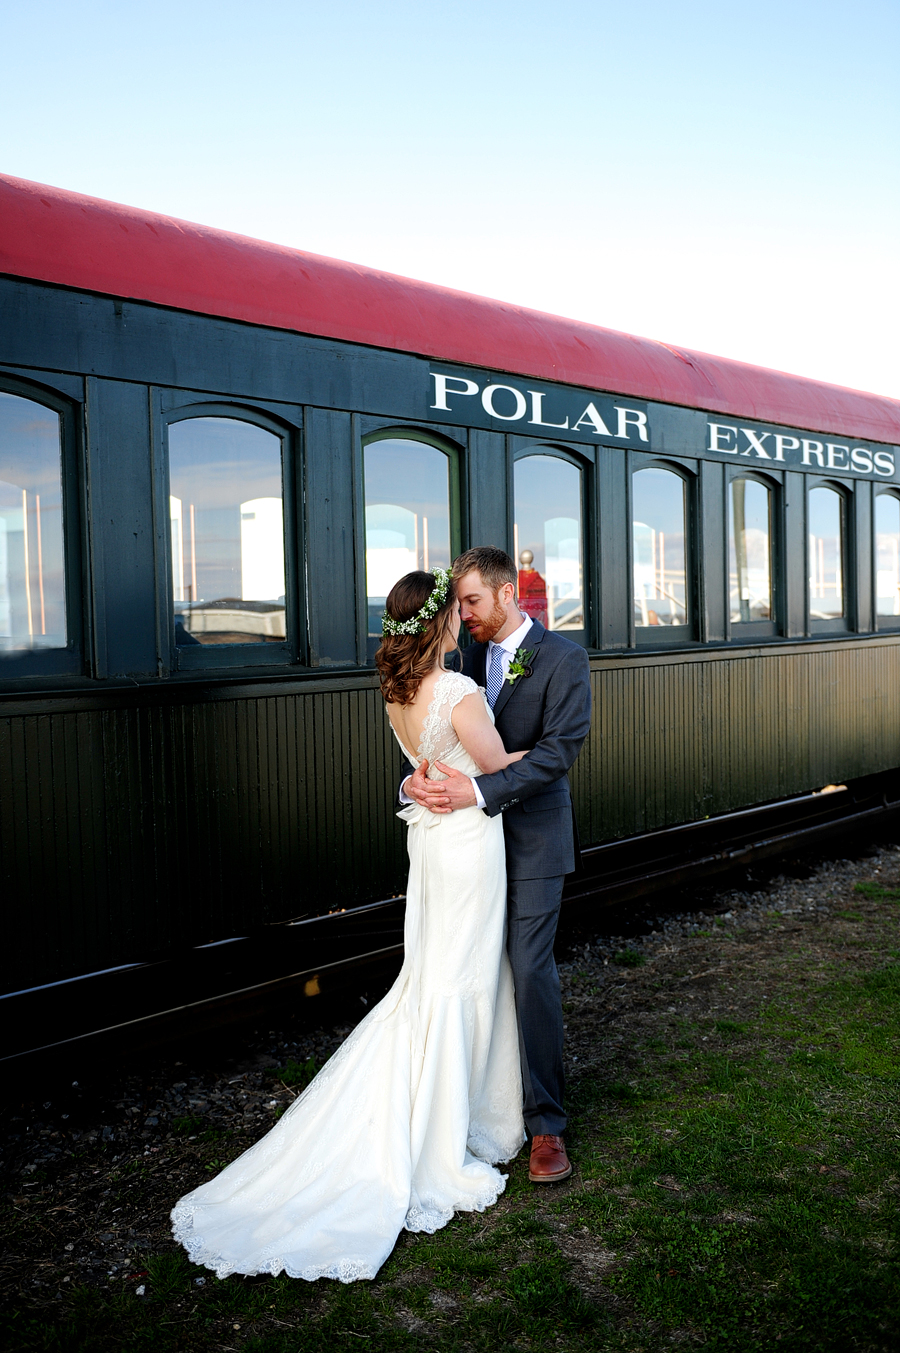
[514,455,585,630]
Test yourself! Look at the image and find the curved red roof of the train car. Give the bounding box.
[0,175,900,442]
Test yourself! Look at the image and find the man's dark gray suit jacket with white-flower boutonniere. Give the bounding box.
[462,621,590,878]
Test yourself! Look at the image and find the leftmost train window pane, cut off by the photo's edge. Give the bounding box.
[0,392,66,652]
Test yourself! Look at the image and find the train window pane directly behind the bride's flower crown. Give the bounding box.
[364,437,451,639]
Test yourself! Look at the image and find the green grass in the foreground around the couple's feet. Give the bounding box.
[0,885,900,1353]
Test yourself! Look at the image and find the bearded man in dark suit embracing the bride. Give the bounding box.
[401,545,590,1184]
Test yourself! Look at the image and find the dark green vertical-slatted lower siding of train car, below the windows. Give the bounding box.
[0,641,900,989]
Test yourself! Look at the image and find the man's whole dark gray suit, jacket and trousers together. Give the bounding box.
[463,621,590,1135]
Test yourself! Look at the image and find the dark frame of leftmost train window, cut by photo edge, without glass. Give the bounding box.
[0,371,89,689]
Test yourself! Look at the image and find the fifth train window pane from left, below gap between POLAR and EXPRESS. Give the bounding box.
[632,469,688,629]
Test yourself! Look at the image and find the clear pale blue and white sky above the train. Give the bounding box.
[0,0,900,398]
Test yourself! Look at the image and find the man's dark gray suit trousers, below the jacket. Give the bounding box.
[506,875,566,1137]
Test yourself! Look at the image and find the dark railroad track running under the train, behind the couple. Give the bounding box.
[0,771,900,1068]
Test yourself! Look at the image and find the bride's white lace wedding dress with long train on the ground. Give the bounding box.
[172,672,525,1283]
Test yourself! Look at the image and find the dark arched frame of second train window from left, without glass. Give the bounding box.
[154,400,306,674]
